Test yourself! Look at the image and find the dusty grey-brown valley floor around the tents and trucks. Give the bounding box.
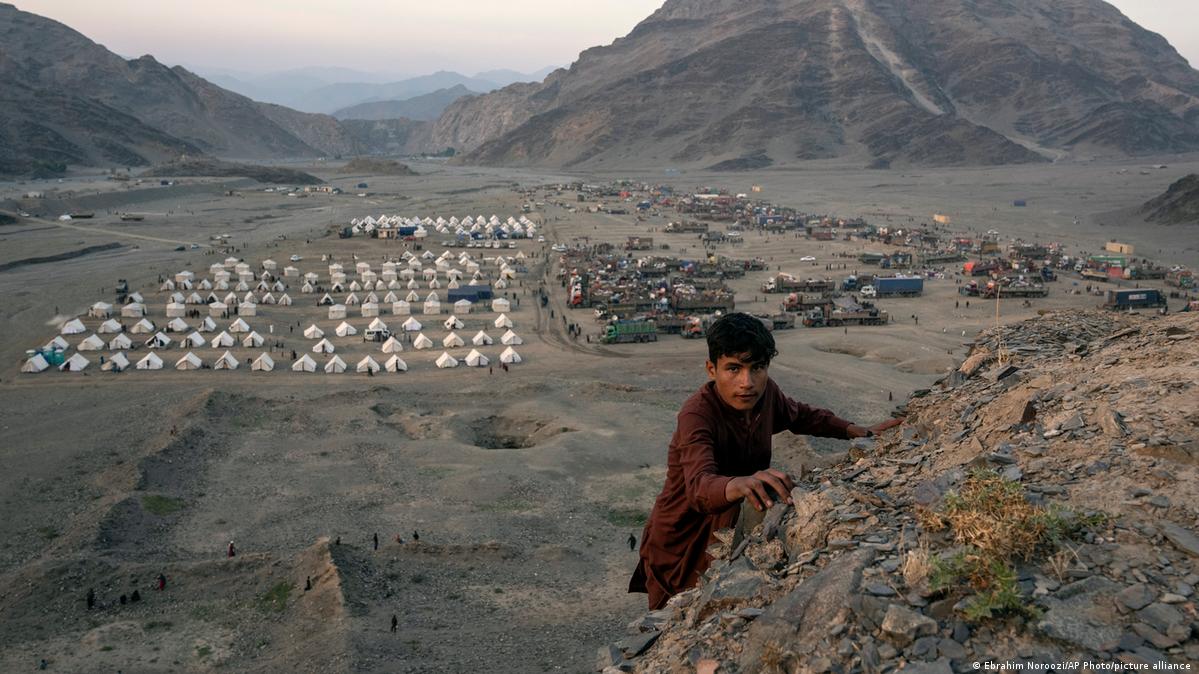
[0,158,1199,672]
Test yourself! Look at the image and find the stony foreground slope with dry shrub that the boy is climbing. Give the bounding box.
[609,312,1199,674]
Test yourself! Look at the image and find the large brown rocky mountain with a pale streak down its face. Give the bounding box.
[433,0,1199,167]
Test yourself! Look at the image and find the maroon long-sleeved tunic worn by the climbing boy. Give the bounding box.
[628,379,850,609]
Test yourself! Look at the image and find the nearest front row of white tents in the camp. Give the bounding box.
[20,347,523,373]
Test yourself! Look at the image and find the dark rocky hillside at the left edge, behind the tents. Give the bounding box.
[0,4,354,173]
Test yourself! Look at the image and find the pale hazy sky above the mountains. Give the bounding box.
[13,0,1199,74]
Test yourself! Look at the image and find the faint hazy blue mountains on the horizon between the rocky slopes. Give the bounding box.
[209,67,554,113]
